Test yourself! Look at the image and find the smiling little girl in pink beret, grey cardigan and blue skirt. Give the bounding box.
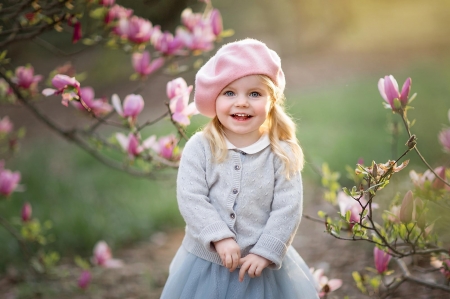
[161,39,318,299]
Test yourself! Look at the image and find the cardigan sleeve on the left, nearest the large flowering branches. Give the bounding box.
[177,133,236,251]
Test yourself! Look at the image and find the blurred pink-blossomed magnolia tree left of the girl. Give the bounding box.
[0,0,233,289]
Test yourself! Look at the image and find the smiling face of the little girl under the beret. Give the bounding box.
[216,75,271,147]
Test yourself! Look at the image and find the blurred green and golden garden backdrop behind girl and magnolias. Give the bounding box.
[0,0,450,294]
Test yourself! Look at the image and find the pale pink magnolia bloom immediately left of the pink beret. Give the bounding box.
[166,78,199,126]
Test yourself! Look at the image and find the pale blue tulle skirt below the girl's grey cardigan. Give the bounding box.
[161,246,319,299]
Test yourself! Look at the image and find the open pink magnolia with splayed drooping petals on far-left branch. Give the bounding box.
[42,74,80,107]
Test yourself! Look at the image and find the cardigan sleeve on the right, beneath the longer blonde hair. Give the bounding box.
[250,148,303,269]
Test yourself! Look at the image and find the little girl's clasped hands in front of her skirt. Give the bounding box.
[213,238,271,282]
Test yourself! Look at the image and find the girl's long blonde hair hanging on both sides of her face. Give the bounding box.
[203,75,304,179]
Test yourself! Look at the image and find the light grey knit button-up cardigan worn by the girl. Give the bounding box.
[177,132,303,269]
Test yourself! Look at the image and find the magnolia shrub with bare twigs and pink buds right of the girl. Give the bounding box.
[316,76,450,298]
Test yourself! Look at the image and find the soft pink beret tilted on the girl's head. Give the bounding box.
[194,38,286,118]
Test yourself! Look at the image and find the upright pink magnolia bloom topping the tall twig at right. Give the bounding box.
[378,75,411,110]
